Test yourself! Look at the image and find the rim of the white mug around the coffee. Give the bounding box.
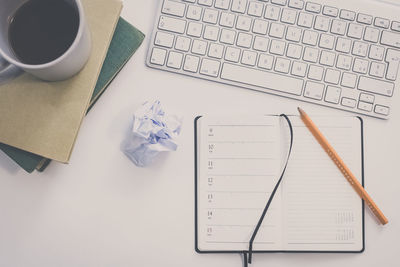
[0,0,86,70]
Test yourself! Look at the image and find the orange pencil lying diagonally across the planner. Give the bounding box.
[297,108,389,225]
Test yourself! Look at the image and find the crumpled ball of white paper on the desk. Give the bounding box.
[122,101,182,167]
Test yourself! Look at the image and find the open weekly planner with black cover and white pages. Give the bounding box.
[195,115,364,253]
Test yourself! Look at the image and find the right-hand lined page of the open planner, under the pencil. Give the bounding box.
[282,117,363,251]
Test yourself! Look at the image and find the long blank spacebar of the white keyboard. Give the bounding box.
[221,63,304,95]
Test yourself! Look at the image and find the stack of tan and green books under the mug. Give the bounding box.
[0,0,144,173]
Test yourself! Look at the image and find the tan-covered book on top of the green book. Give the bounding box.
[0,0,122,163]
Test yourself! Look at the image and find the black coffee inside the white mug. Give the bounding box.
[8,0,79,65]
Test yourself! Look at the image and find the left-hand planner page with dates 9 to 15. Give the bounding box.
[197,116,282,251]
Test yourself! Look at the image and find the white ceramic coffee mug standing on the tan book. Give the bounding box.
[0,0,91,85]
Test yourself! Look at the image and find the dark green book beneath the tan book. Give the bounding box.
[0,18,144,173]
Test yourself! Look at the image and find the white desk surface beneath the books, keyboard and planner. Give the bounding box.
[0,0,400,267]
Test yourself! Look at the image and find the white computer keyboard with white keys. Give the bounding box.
[147,0,400,119]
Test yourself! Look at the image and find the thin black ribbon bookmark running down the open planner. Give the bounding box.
[243,114,293,267]
